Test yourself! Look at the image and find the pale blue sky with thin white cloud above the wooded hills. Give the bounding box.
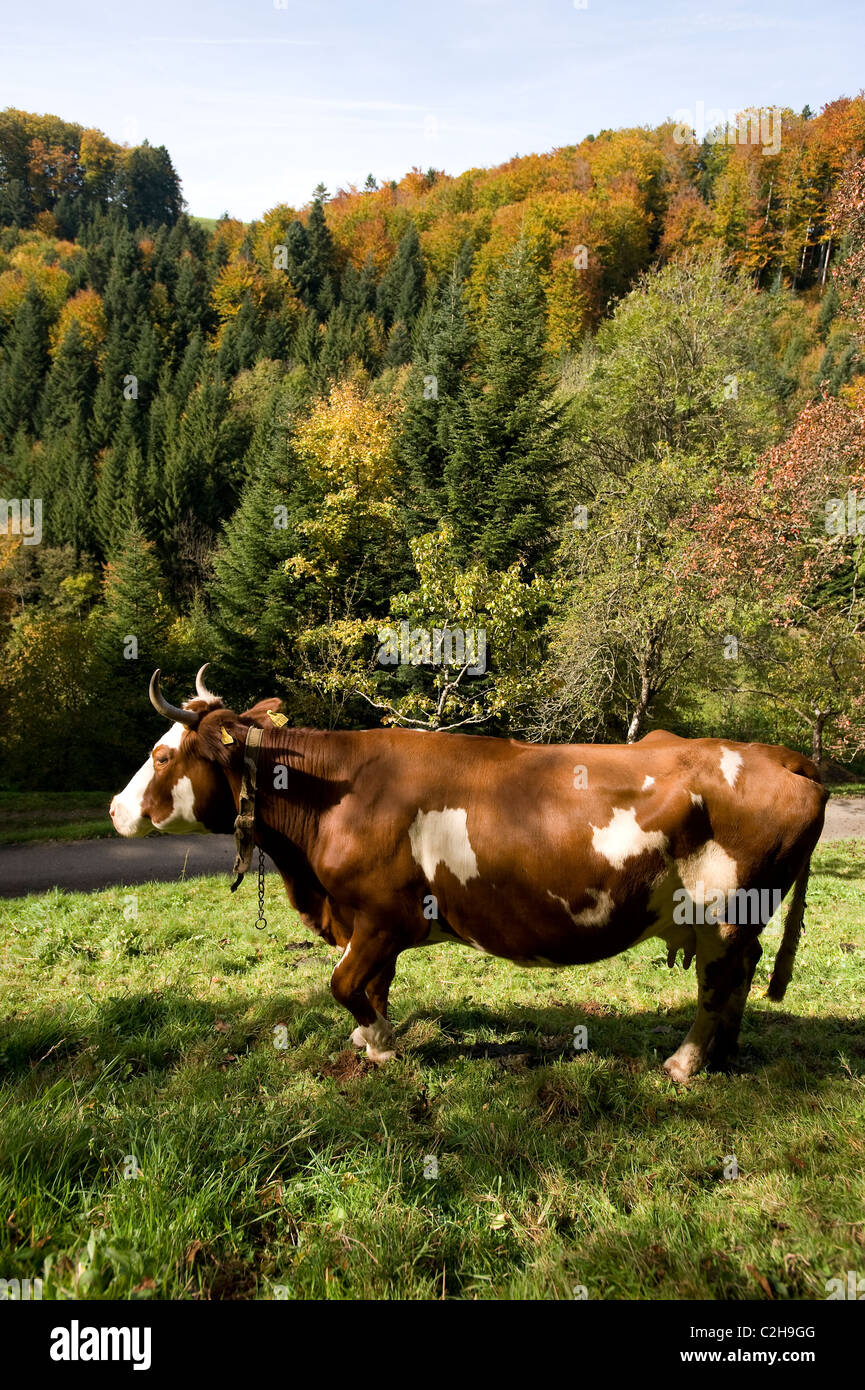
[0,0,865,221]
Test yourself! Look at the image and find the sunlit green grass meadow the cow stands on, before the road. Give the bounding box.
[0,842,865,1300]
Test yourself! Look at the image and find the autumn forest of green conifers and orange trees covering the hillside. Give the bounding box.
[0,93,865,788]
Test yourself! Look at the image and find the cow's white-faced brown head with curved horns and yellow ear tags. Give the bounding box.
[108,666,280,838]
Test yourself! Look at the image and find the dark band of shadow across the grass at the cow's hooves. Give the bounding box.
[0,987,865,1086]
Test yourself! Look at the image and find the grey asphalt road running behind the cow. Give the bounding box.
[0,796,865,898]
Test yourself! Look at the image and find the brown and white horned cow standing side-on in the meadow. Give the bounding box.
[111,669,827,1081]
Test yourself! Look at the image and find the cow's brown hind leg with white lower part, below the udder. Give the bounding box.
[663,924,759,1083]
